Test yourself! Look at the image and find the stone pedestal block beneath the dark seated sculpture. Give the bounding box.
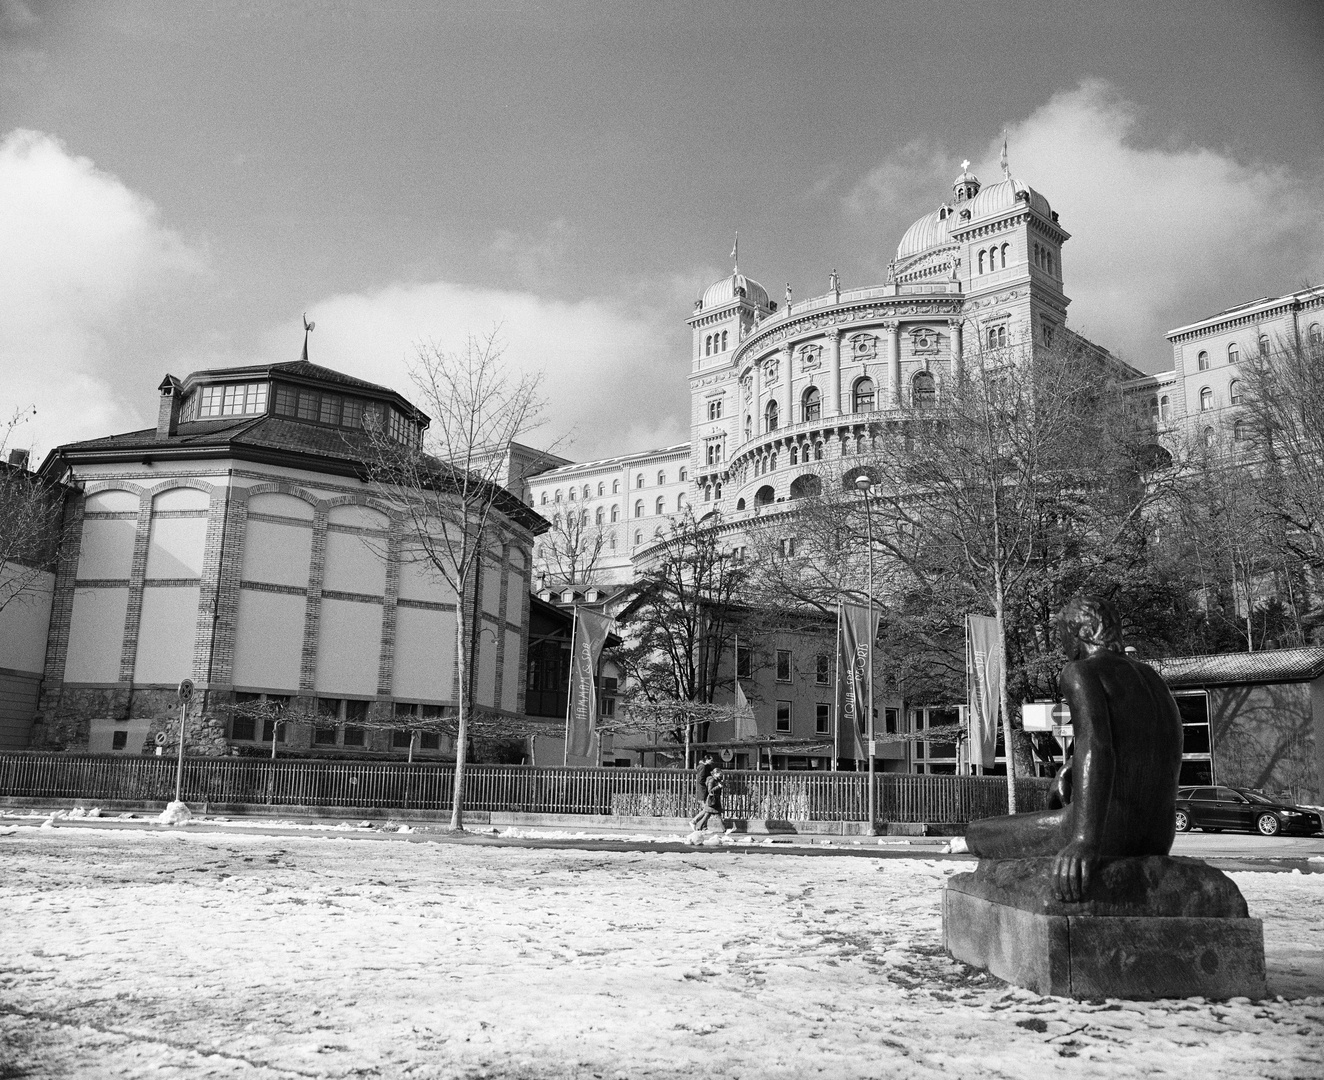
[943,858,1266,1001]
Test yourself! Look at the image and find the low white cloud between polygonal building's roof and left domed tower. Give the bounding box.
[262,281,688,461]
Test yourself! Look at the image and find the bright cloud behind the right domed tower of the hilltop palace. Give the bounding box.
[843,81,1324,371]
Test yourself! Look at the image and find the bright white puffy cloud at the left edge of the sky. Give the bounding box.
[0,130,205,453]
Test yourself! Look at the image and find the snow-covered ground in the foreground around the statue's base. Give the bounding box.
[0,826,1324,1080]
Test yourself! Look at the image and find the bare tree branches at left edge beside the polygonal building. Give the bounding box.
[0,410,64,611]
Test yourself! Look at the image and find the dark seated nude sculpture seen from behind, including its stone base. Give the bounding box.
[943,596,1264,998]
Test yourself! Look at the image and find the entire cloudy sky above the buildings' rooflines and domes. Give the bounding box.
[0,0,1324,459]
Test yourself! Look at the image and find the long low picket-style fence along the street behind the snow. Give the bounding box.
[0,753,1050,825]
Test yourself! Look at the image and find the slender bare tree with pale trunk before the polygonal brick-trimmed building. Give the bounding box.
[368,331,543,831]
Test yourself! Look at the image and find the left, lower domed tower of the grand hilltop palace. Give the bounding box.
[687,265,777,518]
